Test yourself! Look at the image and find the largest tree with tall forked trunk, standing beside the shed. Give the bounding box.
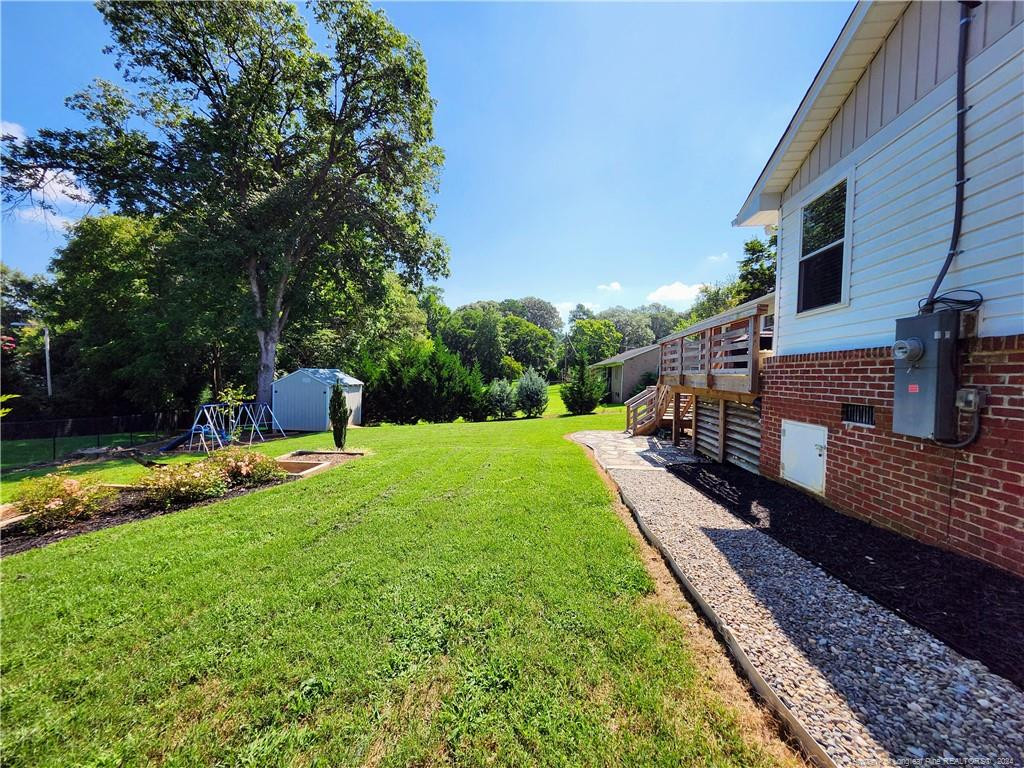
[4,0,446,400]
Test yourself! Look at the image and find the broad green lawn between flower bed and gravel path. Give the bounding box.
[0,397,782,766]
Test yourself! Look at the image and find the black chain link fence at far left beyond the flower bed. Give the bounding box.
[0,411,195,470]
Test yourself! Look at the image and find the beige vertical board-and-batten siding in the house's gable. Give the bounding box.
[782,0,1024,201]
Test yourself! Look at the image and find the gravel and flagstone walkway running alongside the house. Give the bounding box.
[572,431,1024,768]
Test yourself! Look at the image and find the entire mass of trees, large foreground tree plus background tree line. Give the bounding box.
[0,0,773,418]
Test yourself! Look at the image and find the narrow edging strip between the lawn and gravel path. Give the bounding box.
[607,487,838,768]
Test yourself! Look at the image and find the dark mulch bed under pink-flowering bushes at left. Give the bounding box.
[0,480,285,557]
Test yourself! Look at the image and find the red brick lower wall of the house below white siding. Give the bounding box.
[761,336,1024,575]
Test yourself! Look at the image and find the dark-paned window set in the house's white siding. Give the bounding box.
[797,179,846,312]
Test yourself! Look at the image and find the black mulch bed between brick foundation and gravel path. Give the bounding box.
[669,464,1024,688]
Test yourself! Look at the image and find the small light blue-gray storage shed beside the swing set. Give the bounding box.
[272,368,362,432]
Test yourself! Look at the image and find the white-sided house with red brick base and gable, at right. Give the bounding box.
[733,0,1024,574]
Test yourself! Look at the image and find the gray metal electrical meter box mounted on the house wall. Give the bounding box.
[893,311,959,440]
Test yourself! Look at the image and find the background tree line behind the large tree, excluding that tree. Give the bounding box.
[0,228,775,418]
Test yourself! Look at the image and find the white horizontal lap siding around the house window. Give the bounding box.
[775,24,1024,354]
